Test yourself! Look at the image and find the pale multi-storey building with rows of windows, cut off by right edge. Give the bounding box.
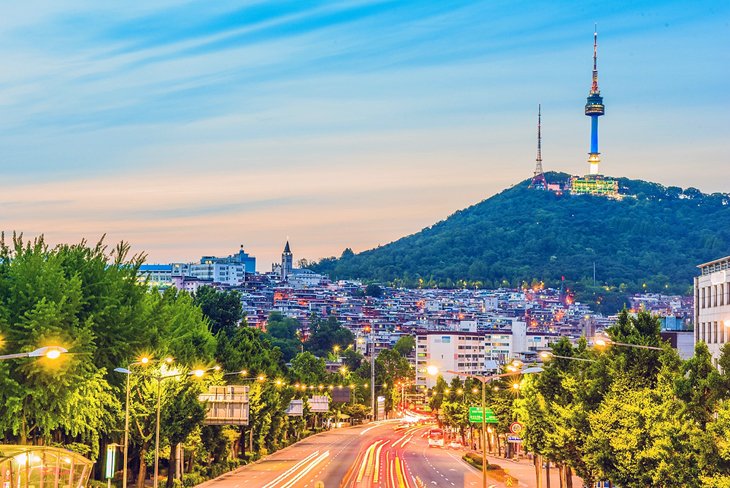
[694,256,730,366]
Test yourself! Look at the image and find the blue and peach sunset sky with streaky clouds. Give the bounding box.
[0,0,730,271]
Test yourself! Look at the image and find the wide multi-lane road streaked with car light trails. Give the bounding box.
[200,421,580,488]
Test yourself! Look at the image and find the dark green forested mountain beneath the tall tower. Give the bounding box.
[310,173,730,302]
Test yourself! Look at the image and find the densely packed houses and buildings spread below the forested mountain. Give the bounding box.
[141,242,693,374]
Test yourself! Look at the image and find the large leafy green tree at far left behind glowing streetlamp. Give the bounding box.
[0,236,129,459]
